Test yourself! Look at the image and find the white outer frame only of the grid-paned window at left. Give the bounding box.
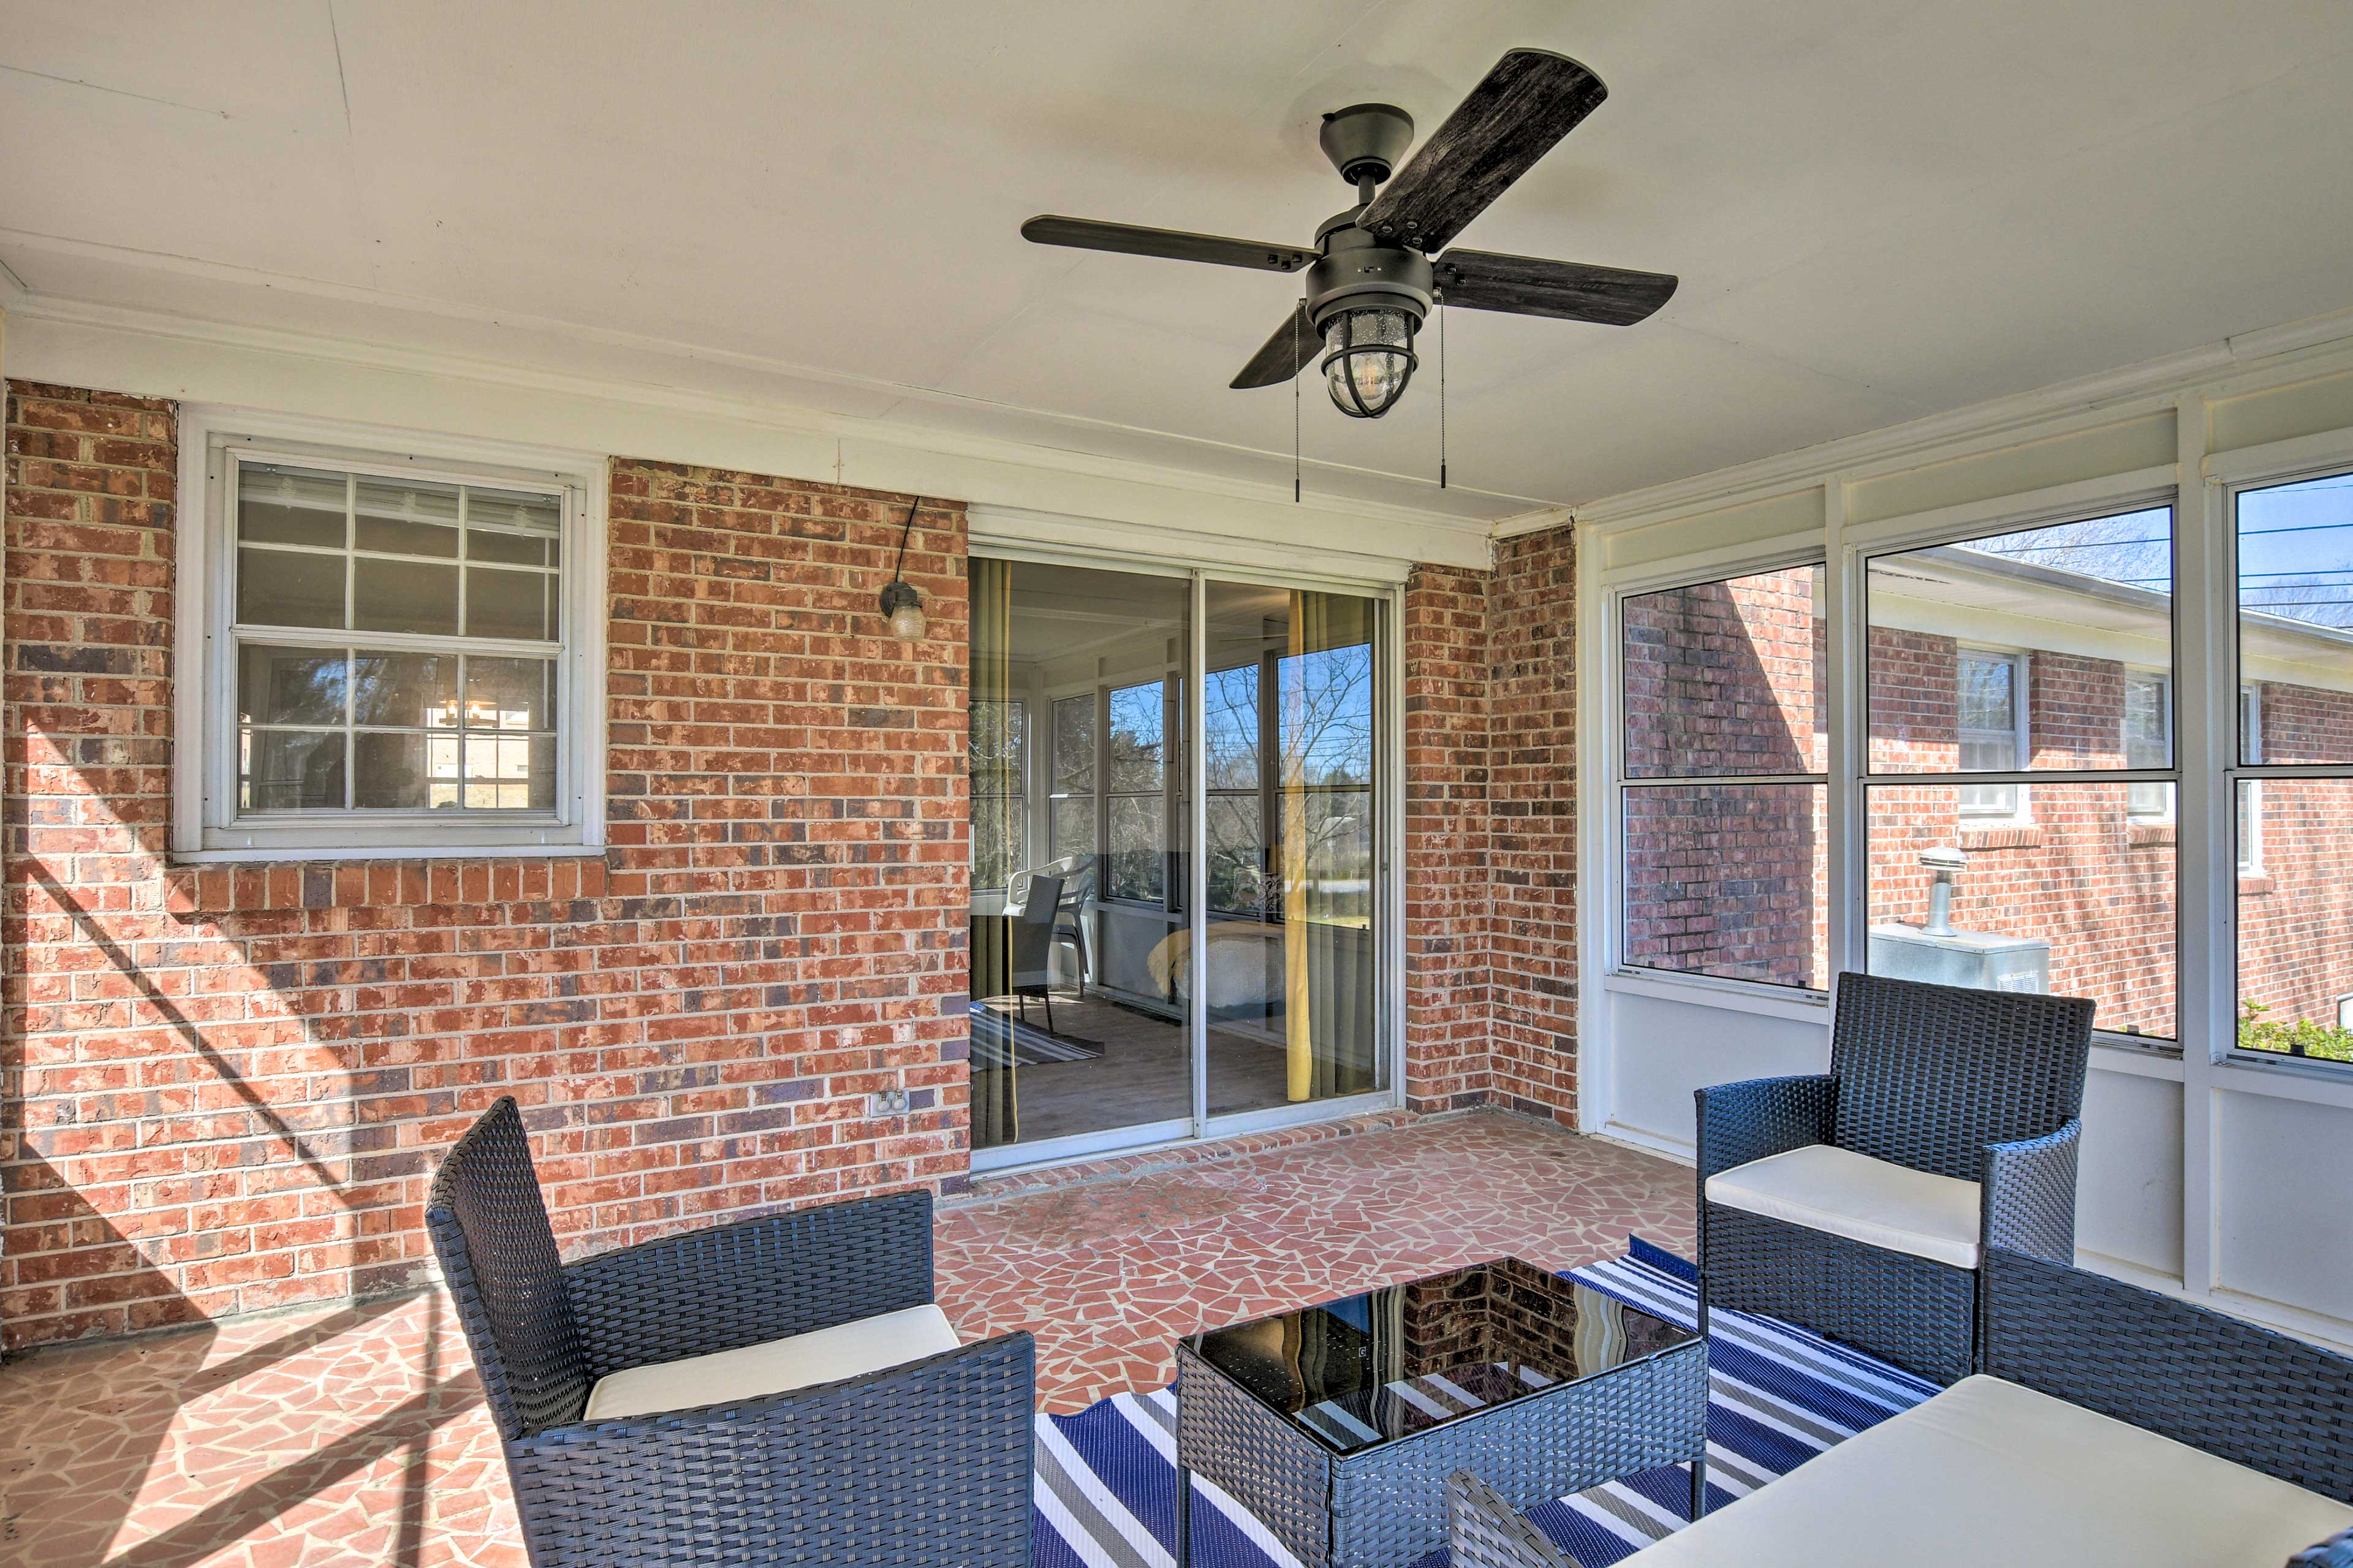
[169,405,607,864]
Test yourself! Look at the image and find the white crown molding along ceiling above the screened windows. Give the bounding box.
[1494,300,2353,539]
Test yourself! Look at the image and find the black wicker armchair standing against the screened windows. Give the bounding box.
[1699,975,2092,1382]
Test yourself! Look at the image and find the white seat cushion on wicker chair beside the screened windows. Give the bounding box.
[1708,1144,1977,1269]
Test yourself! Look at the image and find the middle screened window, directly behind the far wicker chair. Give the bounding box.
[1861,506,2179,1038]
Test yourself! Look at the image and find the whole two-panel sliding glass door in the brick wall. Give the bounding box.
[969,556,1395,1165]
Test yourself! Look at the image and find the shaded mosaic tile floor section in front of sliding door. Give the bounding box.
[936,1113,1697,1415]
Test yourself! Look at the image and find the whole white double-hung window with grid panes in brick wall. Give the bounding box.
[174,414,602,857]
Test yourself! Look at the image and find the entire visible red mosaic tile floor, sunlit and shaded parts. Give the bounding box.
[0,1113,1692,1568]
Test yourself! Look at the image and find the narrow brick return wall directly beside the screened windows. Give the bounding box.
[1487,528,1577,1123]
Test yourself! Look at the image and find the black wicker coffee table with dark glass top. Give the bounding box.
[1176,1257,1708,1568]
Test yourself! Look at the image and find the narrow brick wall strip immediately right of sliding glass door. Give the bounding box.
[1404,555,1494,1112]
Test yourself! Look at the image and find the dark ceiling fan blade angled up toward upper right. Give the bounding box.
[1355,50,1610,252]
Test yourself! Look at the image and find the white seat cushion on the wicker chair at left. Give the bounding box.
[586,1307,960,1422]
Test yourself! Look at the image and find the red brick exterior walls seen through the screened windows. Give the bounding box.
[1624,551,2353,1038]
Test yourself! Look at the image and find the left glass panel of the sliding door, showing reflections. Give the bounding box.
[969,558,1195,1156]
